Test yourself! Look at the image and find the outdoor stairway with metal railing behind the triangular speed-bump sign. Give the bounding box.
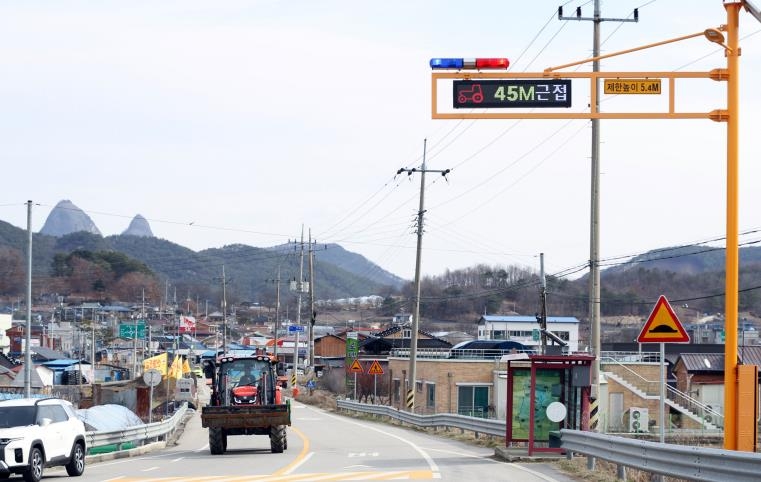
[600,354,724,430]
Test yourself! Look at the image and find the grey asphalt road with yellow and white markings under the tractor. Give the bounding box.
[40,403,573,482]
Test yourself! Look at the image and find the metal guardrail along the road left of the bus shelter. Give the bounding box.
[337,400,506,437]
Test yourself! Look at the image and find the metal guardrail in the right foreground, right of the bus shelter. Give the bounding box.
[560,429,761,482]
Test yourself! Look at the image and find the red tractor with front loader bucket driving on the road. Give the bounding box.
[201,354,291,455]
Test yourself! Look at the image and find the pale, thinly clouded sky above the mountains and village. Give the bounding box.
[0,0,761,279]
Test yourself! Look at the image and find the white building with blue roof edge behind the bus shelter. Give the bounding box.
[478,315,579,353]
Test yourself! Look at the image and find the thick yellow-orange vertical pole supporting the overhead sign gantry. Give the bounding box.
[724,2,742,450]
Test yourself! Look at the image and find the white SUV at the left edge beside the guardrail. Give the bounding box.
[0,398,86,482]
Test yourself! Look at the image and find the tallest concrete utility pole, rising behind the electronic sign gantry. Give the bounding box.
[558,0,639,410]
